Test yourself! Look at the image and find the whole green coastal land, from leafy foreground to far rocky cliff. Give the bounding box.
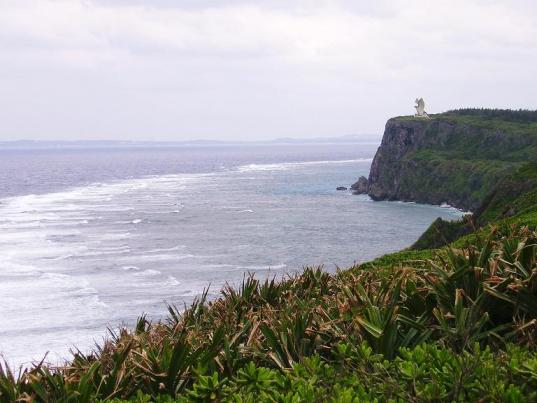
[0,109,537,402]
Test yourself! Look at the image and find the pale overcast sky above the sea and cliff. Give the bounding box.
[0,0,537,141]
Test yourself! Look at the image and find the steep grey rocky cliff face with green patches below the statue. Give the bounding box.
[367,118,535,211]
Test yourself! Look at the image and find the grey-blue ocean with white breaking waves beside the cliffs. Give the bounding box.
[0,143,461,366]
